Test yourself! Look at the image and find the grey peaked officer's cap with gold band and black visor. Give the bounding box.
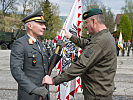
[22,10,46,23]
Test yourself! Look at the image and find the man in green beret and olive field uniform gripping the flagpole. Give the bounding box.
[43,8,117,100]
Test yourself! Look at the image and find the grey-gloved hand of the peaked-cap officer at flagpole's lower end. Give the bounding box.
[31,86,48,99]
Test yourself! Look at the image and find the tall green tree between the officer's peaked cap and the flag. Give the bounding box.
[41,0,62,39]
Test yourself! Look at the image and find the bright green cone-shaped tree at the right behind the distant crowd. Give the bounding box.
[118,14,132,42]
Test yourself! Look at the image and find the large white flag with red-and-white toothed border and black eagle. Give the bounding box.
[56,0,82,100]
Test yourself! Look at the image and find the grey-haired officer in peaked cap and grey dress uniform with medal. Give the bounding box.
[10,10,49,100]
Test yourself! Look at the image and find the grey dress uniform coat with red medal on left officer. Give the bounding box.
[10,34,49,100]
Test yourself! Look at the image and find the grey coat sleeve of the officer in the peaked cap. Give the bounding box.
[10,41,37,93]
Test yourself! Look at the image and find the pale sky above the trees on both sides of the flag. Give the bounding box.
[49,0,125,16]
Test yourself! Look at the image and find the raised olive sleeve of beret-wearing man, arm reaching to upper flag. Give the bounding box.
[70,35,89,49]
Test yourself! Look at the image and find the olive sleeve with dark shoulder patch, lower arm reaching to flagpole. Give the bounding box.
[53,44,103,85]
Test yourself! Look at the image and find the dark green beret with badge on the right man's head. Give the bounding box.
[83,8,103,20]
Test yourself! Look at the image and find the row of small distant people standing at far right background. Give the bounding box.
[116,39,133,56]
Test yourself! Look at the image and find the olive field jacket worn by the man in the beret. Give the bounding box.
[53,29,117,100]
